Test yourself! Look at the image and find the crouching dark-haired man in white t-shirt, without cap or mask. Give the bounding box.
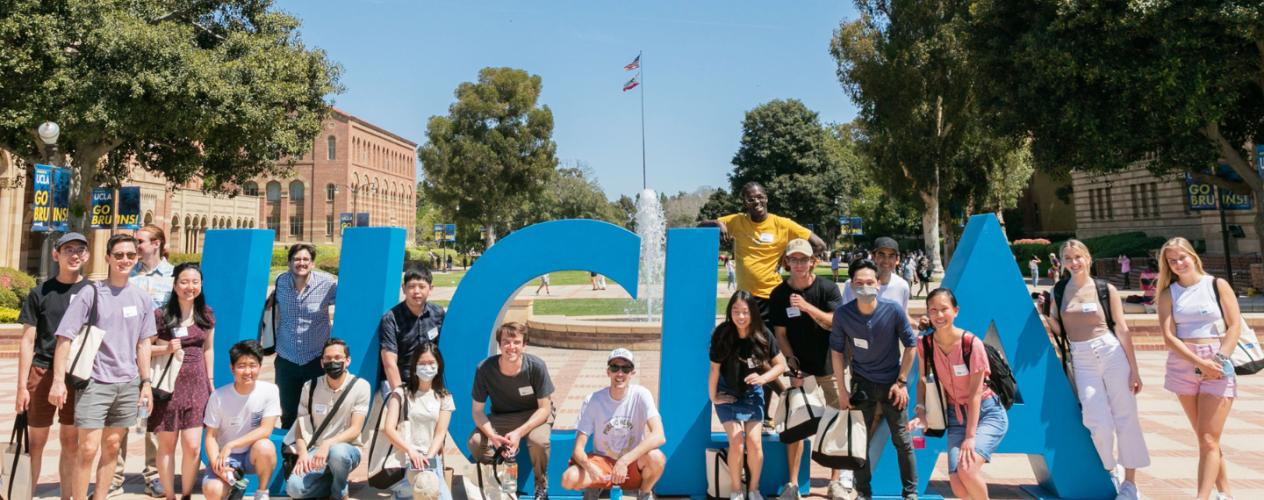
[202,340,281,500]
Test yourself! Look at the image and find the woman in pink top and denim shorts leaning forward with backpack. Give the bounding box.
[909,288,1010,500]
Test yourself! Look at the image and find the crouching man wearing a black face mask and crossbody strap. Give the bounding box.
[284,337,373,499]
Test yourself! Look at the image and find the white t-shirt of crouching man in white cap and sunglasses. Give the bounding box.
[575,385,659,460]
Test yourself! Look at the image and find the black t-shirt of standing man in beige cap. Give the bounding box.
[769,277,843,376]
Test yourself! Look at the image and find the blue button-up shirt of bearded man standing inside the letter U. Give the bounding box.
[277,270,337,365]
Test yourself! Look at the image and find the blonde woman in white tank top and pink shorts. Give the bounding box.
[1158,237,1241,500]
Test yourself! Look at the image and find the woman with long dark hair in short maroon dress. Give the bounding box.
[149,263,215,500]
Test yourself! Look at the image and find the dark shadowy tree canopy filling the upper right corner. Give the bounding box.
[966,0,1264,247]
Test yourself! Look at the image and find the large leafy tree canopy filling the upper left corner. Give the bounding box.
[0,0,343,230]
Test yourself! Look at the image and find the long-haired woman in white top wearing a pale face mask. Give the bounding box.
[383,342,456,500]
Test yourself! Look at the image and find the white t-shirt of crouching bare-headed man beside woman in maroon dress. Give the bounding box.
[202,380,281,453]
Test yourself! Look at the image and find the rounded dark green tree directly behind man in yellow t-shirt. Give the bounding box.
[728,100,844,231]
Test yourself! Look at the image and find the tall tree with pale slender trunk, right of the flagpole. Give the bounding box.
[830,0,1025,278]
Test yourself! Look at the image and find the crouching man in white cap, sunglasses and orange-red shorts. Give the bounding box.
[561,348,667,500]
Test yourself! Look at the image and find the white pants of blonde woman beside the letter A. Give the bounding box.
[1071,333,1150,470]
